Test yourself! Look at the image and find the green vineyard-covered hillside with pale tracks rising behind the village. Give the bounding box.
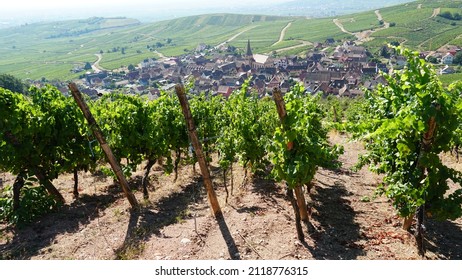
[0,0,462,80]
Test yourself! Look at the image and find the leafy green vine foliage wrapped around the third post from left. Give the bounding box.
[269,85,343,188]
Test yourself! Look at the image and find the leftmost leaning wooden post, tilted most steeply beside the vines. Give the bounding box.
[69,83,139,209]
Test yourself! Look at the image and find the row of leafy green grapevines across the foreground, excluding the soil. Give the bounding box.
[0,48,462,253]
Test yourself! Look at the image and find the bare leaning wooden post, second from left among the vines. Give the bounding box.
[175,84,223,218]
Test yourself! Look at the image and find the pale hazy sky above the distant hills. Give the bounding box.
[0,0,290,23]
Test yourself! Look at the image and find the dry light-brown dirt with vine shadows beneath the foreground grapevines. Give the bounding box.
[0,134,462,260]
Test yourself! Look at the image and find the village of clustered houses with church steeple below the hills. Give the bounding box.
[51,39,460,99]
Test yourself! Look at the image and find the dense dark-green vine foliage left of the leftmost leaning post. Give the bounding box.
[0,86,95,208]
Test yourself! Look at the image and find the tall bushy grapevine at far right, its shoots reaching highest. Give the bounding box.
[355,47,462,219]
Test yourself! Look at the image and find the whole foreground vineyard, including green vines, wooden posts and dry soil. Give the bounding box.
[0,48,462,259]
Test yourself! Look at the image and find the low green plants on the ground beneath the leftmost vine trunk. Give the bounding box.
[0,185,58,225]
